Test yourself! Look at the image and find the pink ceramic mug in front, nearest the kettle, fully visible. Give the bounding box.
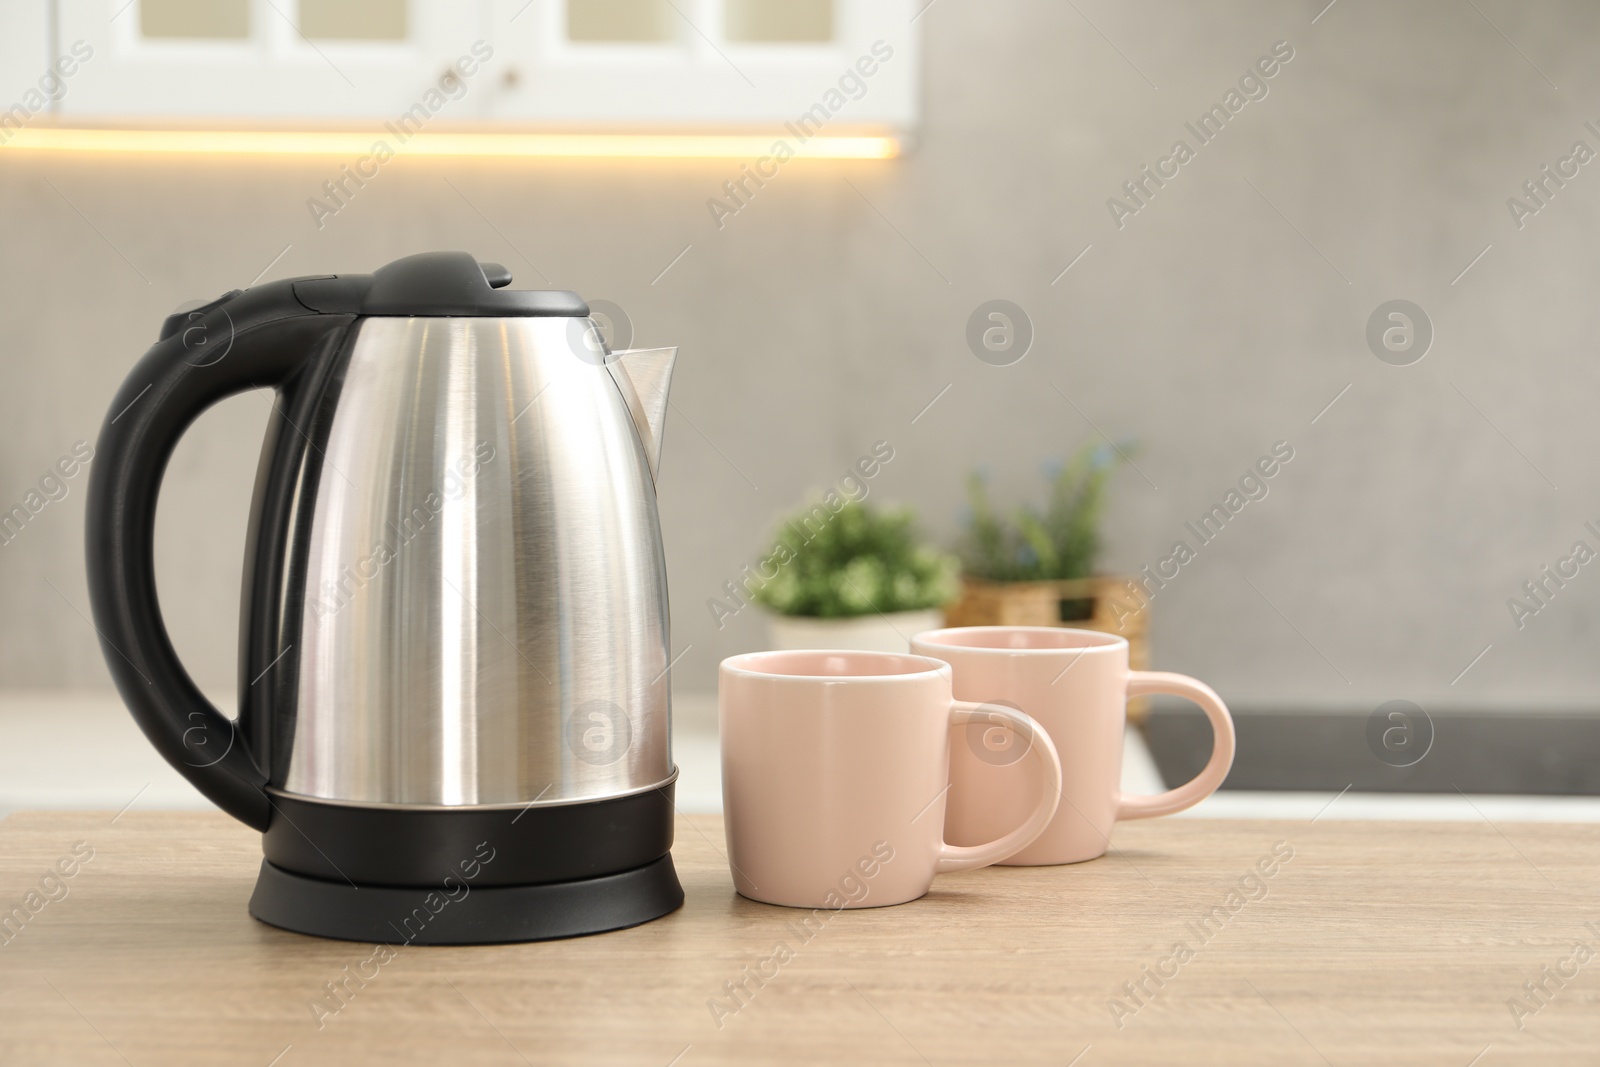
[717,651,1061,910]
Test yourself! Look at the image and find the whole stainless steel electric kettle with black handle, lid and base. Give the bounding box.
[86,253,683,944]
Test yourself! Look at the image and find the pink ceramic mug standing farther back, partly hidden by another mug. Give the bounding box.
[910,625,1234,865]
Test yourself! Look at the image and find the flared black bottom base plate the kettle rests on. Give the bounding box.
[250,853,683,945]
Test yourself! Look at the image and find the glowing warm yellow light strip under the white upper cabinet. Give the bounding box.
[0,126,899,160]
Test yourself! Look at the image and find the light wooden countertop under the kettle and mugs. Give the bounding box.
[0,811,1600,1067]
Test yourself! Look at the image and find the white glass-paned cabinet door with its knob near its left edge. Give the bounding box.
[490,0,917,133]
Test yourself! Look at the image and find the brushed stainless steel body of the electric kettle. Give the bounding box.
[288,317,672,806]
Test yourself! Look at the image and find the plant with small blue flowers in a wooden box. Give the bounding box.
[946,443,1149,697]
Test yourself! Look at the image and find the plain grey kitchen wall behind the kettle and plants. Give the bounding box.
[0,0,1600,707]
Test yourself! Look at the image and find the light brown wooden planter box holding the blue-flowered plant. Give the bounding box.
[944,576,1150,723]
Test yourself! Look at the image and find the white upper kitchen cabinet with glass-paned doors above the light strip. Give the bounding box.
[0,0,925,136]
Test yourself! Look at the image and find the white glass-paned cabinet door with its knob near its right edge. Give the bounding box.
[60,0,498,126]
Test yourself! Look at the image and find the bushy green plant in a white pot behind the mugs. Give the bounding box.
[752,498,962,653]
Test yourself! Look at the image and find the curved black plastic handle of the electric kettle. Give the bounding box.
[85,294,354,830]
